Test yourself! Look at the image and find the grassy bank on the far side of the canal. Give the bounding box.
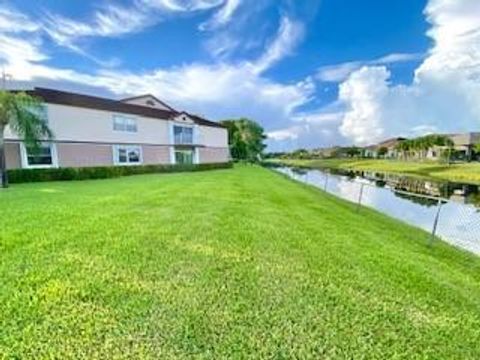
[274,159,480,184]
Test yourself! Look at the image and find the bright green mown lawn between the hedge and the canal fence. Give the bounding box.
[0,166,480,359]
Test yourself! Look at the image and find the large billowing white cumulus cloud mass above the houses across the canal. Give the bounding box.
[340,0,480,144]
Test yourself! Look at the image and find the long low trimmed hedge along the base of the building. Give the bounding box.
[7,162,233,184]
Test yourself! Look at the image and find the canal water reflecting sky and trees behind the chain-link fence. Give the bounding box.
[275,166,480,254]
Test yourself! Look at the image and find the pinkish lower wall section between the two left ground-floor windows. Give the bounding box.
[56,143,113,167]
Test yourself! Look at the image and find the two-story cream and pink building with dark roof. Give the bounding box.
[5,88,230,169]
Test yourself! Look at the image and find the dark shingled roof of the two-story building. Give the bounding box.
[21,87,224,128]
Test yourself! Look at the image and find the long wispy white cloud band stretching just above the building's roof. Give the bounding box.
[0,7,314,142]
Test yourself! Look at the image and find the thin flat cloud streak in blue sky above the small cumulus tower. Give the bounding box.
[317,53,422,82]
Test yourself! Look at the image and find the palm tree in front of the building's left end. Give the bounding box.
[0,90,53,188]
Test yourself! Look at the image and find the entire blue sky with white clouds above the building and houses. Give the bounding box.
[0,0,480,150]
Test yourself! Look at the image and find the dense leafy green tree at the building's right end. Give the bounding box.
[221,118,267,161]
